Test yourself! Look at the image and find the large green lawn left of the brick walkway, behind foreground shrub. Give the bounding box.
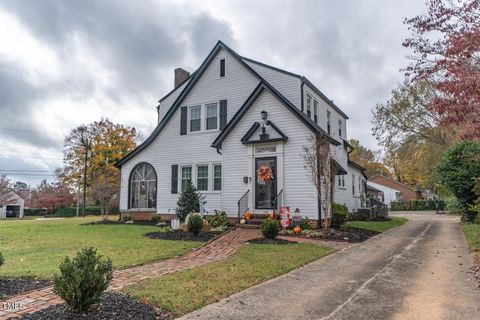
[0,217,201,279]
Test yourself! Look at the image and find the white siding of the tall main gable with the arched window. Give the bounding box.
[120,50,258,213]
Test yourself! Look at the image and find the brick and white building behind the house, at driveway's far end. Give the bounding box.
[368,174,419,204]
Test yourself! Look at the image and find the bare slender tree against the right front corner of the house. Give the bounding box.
[303,135,339,232]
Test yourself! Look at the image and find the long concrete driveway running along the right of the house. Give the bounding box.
[182,213,480,320]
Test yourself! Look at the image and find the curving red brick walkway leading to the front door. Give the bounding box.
[0,229,261,320]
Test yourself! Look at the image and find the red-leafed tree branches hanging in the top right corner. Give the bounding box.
[404,0,480,139]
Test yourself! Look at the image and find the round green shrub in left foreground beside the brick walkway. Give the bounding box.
[53,247,113,312]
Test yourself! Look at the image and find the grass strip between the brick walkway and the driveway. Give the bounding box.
[124,244,333,316]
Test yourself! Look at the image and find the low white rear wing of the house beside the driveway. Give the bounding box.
[333,160,367,211]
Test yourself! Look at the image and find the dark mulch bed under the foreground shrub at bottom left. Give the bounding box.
[16,292,172,320]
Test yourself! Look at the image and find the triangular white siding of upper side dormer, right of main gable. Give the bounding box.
[245,61,301,109]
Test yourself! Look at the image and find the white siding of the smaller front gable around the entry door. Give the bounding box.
[222,92,318,219]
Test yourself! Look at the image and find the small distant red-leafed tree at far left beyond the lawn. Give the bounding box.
[31,180,74,213]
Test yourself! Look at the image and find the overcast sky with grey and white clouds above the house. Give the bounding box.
[0,0,425,185]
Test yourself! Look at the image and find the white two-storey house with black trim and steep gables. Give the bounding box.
[117,41,372,225]
